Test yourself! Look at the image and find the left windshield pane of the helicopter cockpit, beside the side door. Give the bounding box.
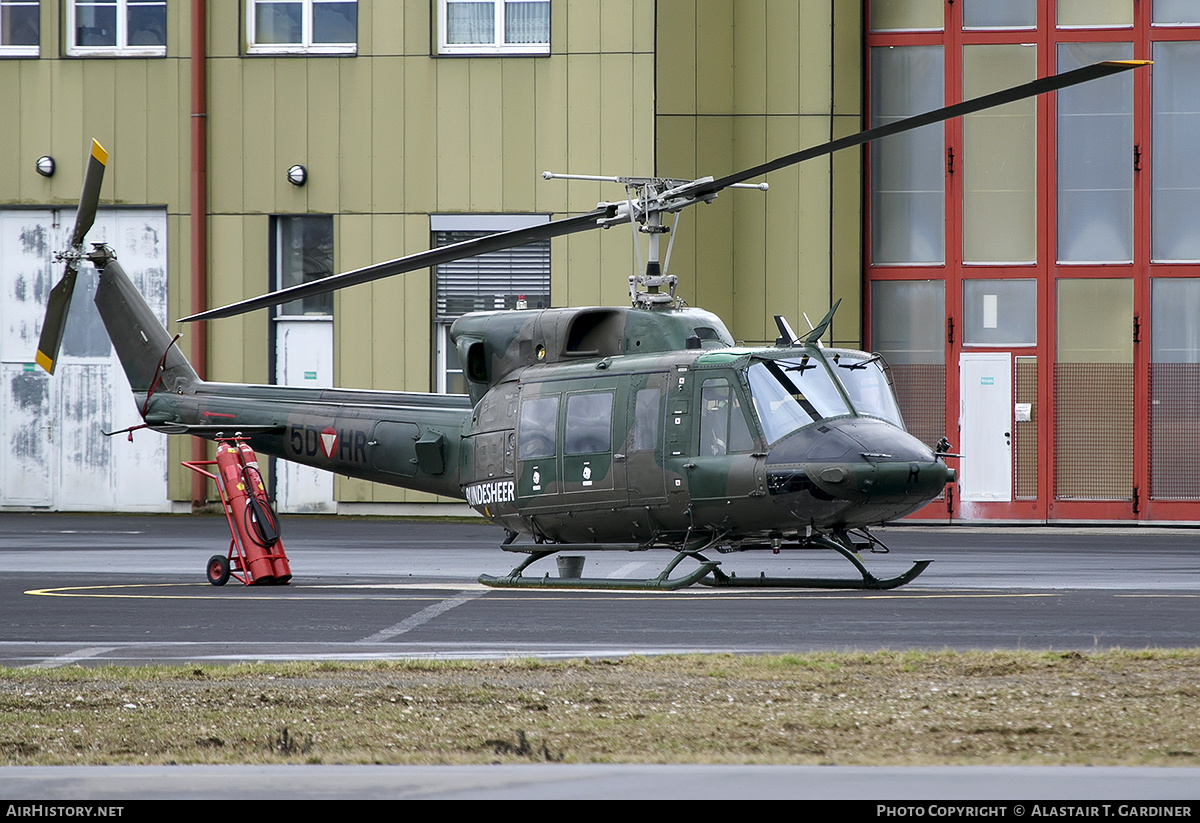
[746,355,850,443]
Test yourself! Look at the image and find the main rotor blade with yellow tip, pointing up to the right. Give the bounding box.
[674,60,1151,198]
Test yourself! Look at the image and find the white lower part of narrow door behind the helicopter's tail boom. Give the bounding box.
[275,316,337,513]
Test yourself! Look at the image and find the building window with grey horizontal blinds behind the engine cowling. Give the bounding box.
[430,215,550,395]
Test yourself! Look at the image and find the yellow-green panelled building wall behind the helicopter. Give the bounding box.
[0,0,862,503]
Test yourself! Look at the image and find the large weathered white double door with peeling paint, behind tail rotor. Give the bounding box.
[0,209,170,511]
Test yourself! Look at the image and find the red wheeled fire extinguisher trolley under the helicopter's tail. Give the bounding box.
[182,435,292,585]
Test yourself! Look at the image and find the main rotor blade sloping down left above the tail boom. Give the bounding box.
[180,205,629,323]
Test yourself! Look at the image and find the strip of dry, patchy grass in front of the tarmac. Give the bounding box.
[0,650,1200,765]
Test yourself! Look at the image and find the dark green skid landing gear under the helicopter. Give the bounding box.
[479,531,931,591]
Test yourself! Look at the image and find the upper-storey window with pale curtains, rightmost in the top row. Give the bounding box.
[438,0,550,54]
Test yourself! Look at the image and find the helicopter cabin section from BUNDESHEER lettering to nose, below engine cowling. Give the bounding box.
[453,316,953,547]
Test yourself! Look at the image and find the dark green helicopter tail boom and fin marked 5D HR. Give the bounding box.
[88,246,470,497]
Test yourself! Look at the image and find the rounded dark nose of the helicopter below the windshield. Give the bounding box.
[767,417,955,505]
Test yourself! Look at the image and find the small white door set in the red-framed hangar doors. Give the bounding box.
[959,352,1013,503]
